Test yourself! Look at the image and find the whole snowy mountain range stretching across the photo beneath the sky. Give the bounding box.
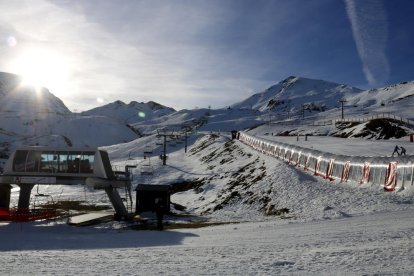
[0,72,414,153]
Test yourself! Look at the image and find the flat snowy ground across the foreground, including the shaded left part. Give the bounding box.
[0,210,414,275]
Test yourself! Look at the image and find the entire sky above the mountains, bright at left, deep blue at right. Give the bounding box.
[0,0,414,111]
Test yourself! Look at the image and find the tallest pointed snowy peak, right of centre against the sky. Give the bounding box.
[232,76,362,113]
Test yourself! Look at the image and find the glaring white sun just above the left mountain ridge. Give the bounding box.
[13,48,69,94]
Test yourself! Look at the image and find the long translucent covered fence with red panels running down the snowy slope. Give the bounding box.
[239,132,414,191]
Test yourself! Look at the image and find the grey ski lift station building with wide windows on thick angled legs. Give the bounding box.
[0,147,131,218]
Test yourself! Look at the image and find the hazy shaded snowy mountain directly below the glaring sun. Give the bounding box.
[0,72,137,150]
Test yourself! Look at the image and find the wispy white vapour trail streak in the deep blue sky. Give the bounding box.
[344,0,390,85]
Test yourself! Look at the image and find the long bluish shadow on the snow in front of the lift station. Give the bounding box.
[0,223,198,251]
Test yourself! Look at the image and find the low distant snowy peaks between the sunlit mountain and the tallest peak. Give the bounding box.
[81,100,175,124]
